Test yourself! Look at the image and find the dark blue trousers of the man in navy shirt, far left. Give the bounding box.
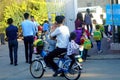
[8,39,18,64]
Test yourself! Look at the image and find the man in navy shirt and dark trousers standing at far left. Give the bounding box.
[6,18,18,66]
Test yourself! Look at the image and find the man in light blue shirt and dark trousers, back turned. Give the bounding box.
[21,13,36,63]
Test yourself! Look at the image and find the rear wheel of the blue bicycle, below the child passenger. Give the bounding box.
[63,60,81,80]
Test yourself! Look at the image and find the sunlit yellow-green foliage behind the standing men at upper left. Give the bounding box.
[0,0,55,31]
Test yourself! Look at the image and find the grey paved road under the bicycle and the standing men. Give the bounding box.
[0,41,120,80]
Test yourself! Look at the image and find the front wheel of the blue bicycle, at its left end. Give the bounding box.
[30,60,44,78]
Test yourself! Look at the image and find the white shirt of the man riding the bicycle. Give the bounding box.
[51,25,70,48]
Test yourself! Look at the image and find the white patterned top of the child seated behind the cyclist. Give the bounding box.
[67,40,79,55]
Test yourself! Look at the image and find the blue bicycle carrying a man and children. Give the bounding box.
[30,50,82,80]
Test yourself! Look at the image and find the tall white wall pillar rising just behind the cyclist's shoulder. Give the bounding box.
[65,0,77,31]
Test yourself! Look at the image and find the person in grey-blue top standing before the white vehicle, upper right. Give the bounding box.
[84,9,93,34]
